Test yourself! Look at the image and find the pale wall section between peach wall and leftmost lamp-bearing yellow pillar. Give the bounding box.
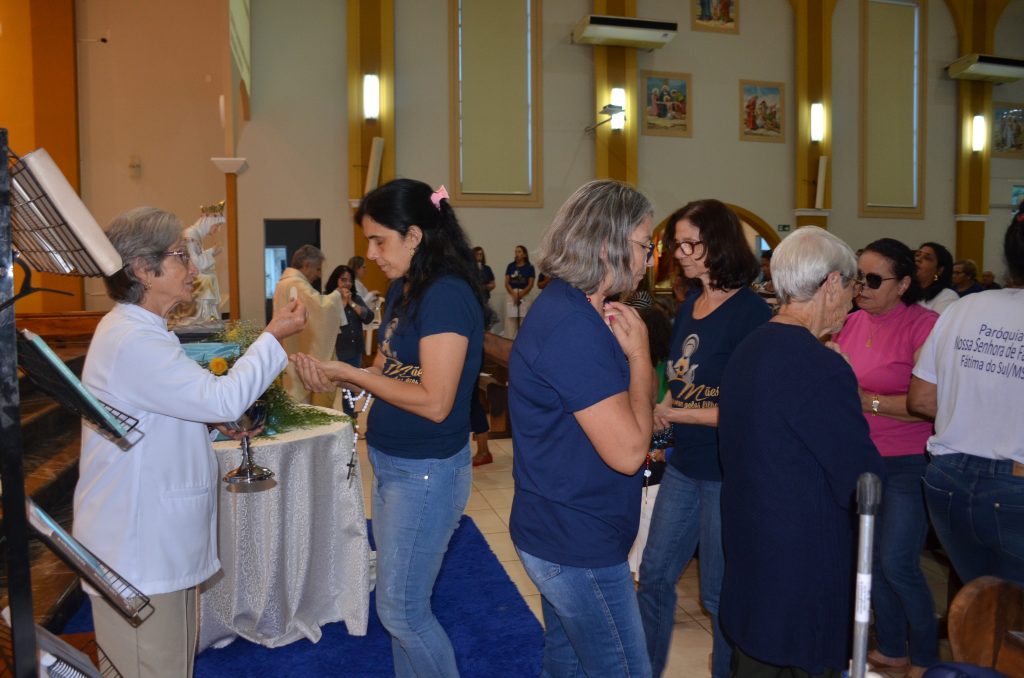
[237,0,352,321]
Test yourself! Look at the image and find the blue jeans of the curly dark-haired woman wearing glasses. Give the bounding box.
[637,467,732,678]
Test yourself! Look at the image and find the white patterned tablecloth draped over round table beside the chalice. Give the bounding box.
[199,422,370,650]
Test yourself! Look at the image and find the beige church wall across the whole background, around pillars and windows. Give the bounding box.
[79,0,1024,319]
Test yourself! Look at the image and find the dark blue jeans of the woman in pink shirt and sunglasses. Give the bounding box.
[871,454,939,667]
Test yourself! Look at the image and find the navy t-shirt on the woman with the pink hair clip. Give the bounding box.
[367,276,483,459]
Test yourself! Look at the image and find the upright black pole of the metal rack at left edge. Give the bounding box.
[0,129,36,678]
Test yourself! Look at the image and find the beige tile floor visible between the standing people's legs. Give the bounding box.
[358,422,948,678]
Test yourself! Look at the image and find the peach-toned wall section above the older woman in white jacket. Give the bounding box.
[76,0,227,310]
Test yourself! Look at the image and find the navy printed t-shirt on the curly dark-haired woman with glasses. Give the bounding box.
[669,287,771,480]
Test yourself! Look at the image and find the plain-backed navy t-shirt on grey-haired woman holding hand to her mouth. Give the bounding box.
[509,280,642,567]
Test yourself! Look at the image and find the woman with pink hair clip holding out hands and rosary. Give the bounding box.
[292,179,486,678]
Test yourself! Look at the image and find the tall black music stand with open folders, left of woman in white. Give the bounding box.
[0,135,142,678]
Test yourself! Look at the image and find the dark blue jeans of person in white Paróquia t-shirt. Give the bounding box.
[925,454,1024,586]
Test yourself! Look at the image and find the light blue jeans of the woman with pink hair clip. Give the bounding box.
[369,443,472,678]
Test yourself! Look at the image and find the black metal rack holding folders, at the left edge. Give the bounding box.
[0,128,144,678]
